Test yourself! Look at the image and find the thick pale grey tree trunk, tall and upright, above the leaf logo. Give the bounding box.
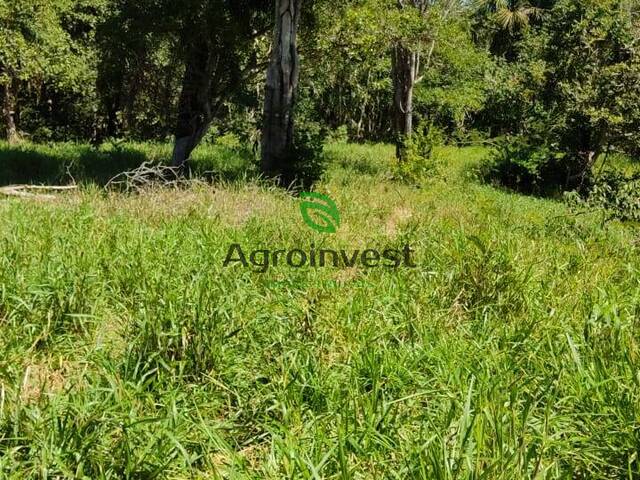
[262,0,302,183]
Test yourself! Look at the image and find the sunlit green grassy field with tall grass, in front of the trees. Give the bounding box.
[0,141,640,479]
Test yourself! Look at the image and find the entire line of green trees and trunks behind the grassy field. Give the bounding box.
[0,0,640,189]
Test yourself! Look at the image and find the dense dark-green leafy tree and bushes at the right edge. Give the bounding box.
[484,0,640,189]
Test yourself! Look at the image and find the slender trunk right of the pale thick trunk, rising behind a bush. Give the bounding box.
[392,45,419,160]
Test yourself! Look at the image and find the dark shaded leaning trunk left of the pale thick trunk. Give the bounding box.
[172,41,215,168]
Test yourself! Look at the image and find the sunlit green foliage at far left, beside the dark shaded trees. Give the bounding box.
[0,0,107,140]
